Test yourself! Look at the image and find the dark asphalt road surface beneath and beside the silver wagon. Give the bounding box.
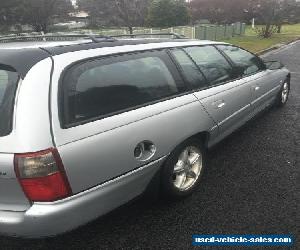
[0,42,300,250]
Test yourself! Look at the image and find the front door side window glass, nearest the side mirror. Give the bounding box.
[218,45,263,76]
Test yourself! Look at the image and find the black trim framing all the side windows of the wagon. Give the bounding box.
[57,43,266,129]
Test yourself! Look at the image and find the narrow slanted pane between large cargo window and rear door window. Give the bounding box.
[171,49,207,89]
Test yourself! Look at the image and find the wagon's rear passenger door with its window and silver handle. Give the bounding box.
[179,46,251,139]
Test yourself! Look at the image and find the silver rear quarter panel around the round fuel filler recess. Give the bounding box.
[55,95,215,193]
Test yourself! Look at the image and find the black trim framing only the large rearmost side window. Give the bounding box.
[57,48,188,129]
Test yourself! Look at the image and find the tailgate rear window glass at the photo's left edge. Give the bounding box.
[0,65,19,136]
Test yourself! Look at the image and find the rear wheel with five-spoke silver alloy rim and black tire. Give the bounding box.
[161,138,206,200]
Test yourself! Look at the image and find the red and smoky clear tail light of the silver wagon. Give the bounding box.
[14,149,72,202]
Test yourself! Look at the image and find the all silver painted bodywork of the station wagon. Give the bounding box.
[0,41,289,237]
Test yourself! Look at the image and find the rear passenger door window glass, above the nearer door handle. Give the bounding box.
[185,46,232,85]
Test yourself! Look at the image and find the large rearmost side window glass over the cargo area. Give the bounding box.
[64,54,179,124]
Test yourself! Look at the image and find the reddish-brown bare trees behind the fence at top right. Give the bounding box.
[190,0,300,38]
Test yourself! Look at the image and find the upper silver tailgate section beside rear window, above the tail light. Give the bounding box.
[0,58,53,153]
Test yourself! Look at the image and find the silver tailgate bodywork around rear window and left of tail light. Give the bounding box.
[0,59,53,211]
